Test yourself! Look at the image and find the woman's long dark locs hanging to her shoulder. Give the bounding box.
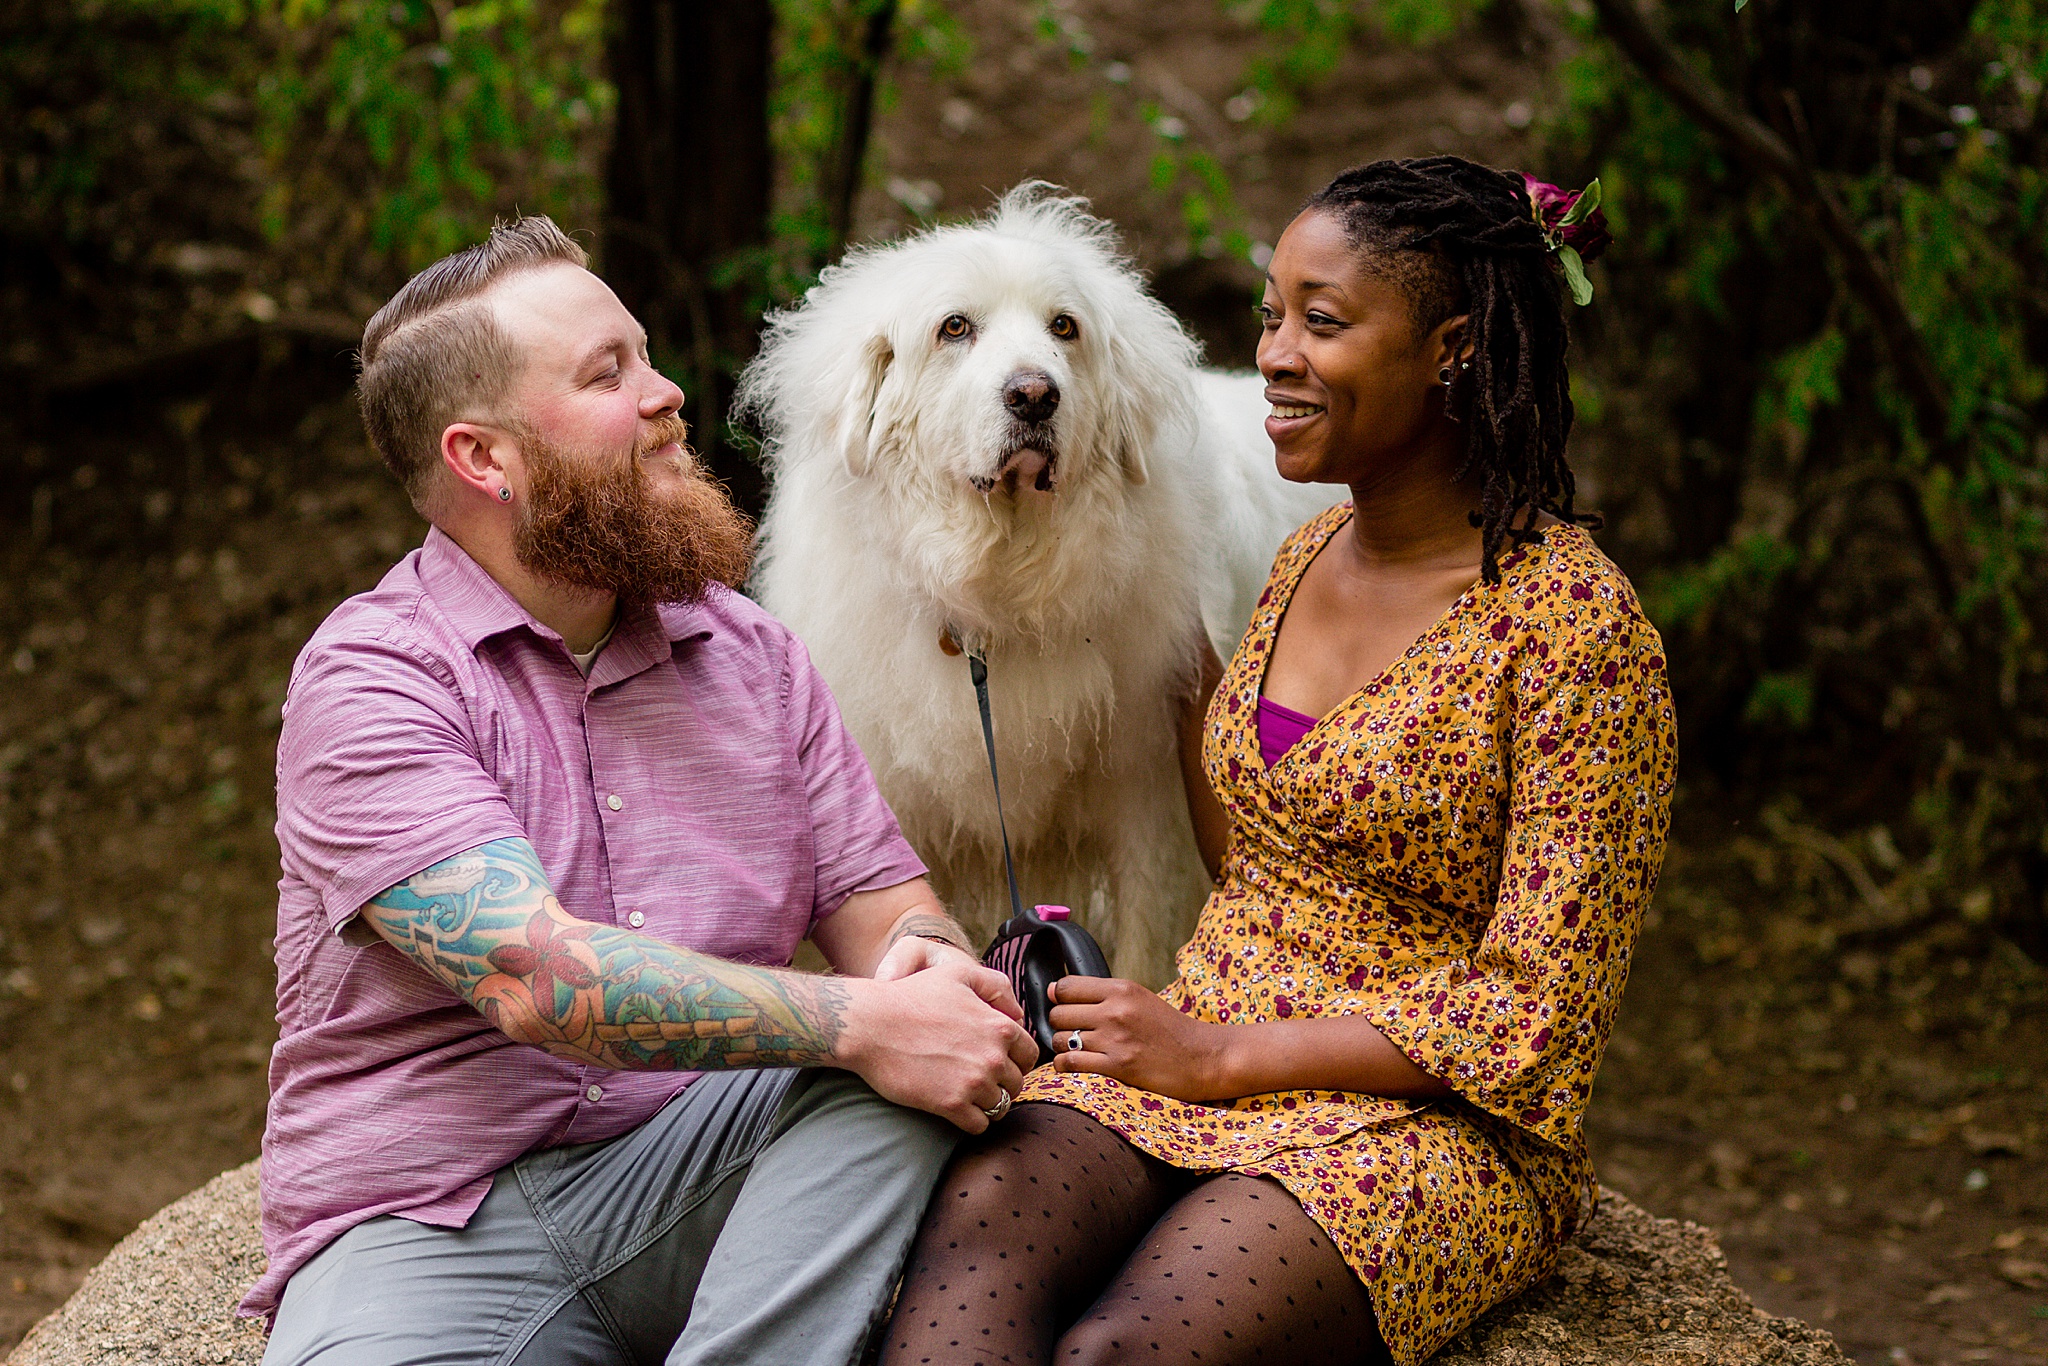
[1303,156,1599,584]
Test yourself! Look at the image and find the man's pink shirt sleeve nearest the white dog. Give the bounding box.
[788,635,926,920]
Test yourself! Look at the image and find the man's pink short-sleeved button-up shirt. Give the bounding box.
[242,530,924,1315]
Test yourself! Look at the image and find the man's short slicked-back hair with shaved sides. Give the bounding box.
[356,215,590,514]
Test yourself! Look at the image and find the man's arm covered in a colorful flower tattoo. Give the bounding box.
[362,840,848,1071]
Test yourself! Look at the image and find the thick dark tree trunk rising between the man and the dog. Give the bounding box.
[600,0,774,514]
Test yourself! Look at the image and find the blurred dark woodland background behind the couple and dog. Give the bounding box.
[0,0,2048,1360]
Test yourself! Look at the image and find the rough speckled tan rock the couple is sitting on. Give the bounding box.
[8,1163,1849,1366]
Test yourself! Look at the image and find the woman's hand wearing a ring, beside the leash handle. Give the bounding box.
[1049,977,1237,1102]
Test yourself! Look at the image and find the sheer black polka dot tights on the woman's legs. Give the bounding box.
[881,1104,1389,1366]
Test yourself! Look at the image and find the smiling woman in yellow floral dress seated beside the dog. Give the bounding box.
[883,158,1675,1366]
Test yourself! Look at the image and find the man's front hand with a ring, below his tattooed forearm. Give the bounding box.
[836,944,1038,1135]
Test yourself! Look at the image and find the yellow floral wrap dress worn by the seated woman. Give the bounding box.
[1020,504,1677,1366]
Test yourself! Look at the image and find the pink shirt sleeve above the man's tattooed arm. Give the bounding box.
[276,637,526,928]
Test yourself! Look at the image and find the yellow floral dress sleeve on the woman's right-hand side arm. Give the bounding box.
[1376,612,1677,1145]
